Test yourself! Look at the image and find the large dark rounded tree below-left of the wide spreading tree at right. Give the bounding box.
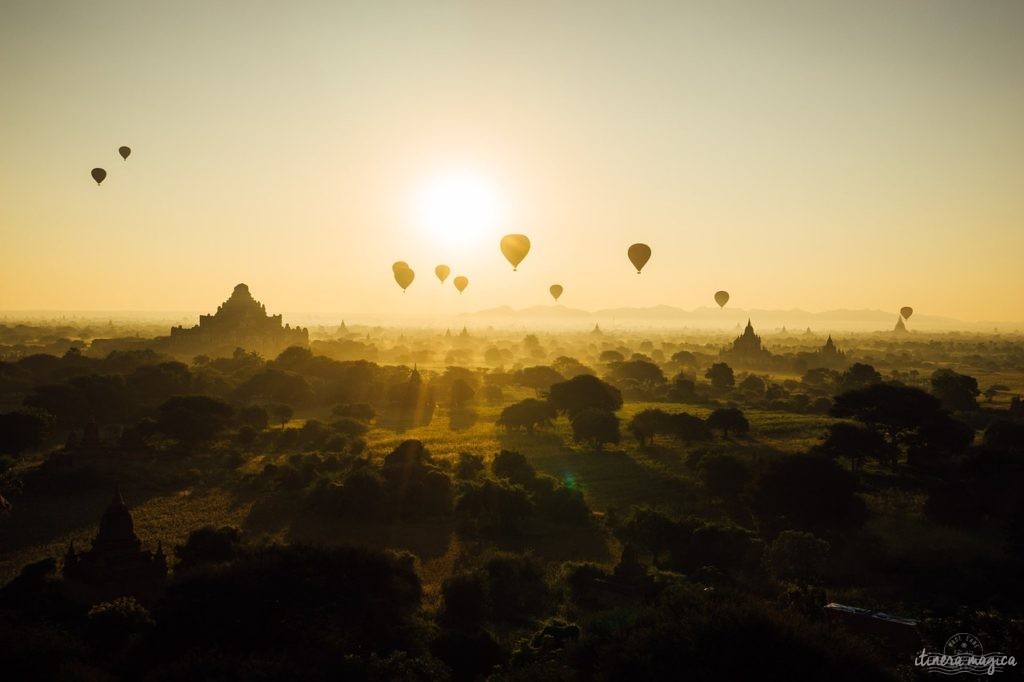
[751,455,867,535]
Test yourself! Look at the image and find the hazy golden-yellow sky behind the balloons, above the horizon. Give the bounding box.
[0,0,1024,321]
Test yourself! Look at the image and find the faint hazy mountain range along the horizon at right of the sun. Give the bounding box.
[463,305,1024,332]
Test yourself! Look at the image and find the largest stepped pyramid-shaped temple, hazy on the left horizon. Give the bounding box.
[167,284,309,357]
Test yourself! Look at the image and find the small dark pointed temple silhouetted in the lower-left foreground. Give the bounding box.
[62,483,167,606]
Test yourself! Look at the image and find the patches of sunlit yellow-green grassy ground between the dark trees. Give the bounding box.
[0,391,828,583]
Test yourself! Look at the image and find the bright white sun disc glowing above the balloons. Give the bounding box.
[416,171,505,247]
